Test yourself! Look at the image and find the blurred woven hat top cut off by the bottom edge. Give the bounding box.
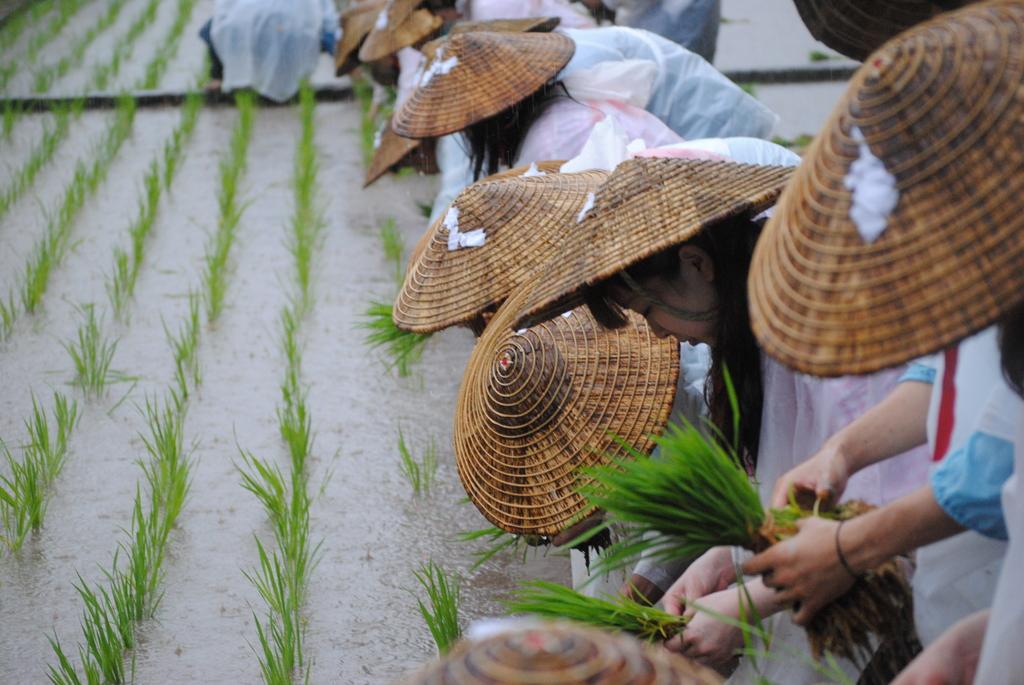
[401,623,722,685]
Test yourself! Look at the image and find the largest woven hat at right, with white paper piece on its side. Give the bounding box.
[750,1,1024,376]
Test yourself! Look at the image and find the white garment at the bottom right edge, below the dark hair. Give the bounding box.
[974,386,1024,685]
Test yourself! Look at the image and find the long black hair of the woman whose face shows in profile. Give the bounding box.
[584,218,764,466]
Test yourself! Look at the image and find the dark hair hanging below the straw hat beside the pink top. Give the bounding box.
[463,81,569,180]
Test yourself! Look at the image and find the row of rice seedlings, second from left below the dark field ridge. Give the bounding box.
[20,96,135,313]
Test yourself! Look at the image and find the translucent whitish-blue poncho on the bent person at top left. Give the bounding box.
[211,0,338,102]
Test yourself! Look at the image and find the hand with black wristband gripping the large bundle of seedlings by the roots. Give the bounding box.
[743,517,854,626]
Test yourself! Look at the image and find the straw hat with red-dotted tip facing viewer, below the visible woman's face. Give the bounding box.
[455,284,679,537]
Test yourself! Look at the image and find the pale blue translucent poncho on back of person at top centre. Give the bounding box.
[558,27,778,139]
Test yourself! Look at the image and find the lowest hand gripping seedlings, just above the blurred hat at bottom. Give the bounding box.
[665,588,743,675]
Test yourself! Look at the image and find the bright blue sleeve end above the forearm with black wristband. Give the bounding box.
[931,431,1014,540]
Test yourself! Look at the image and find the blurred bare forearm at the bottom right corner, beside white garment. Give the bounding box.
[893,610,988,685]
